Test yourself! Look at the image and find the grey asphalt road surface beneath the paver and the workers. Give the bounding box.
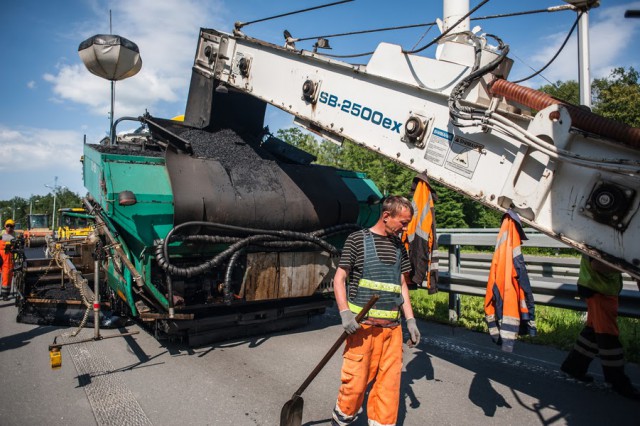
[0,290,640,426]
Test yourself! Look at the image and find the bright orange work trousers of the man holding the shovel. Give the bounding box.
[333,324,402,426]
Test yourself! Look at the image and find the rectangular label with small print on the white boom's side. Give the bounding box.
[425,129,484,179]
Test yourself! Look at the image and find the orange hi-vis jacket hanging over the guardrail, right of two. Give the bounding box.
[484,210,536,352]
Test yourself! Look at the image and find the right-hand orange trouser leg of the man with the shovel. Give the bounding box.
[367,326,402,426]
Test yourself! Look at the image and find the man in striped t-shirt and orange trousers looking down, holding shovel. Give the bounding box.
[332,196,420,426]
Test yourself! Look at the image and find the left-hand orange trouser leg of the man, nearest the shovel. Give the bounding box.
[333,324,375,426]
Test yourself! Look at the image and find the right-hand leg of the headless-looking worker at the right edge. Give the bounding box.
[588,294,640,399]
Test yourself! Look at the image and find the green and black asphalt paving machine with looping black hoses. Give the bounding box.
[83,101,381,345]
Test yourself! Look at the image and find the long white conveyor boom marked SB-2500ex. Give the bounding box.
[185,29,640,278]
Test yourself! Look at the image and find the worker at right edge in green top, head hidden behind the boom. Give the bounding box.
[560,255,640,400]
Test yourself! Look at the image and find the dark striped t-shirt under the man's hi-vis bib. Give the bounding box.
[338,231,411,299]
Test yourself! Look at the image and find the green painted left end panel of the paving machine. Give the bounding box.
[83,145,173,316]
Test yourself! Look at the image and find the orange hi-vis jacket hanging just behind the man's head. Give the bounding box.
[402,173,438,293]
